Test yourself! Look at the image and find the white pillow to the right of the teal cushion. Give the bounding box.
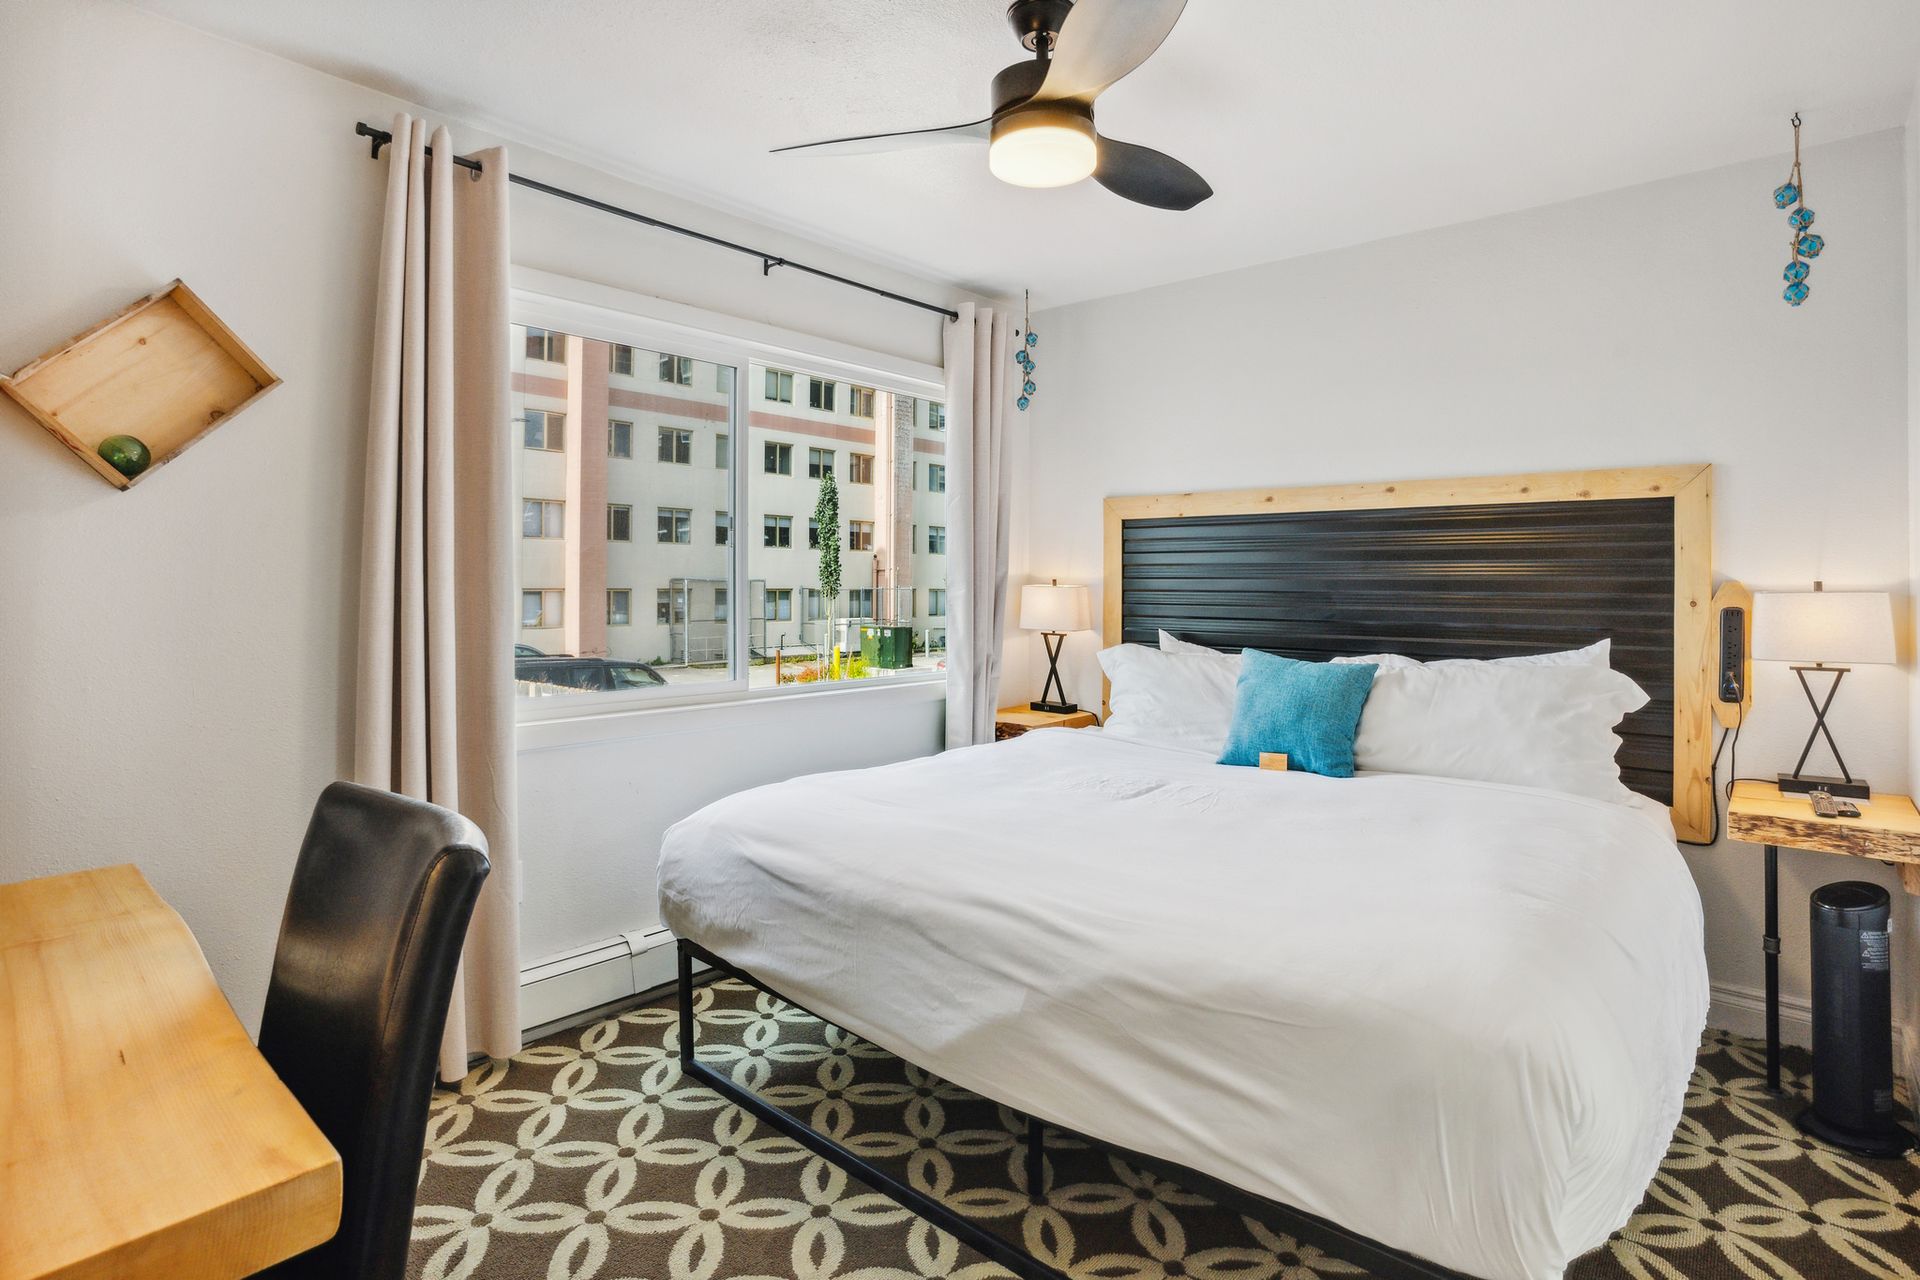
[1354,662,1647,804]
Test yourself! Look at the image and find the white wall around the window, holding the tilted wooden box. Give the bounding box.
[0,0,1013,1023]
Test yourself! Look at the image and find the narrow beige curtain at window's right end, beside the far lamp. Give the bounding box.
[945,303,1012,747]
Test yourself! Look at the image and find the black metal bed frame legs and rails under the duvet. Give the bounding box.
[678,938,1471,1280]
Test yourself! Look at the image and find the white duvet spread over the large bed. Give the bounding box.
[660,729,1707,1280]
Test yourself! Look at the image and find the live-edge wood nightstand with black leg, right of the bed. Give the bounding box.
[1726,783,1920,1092]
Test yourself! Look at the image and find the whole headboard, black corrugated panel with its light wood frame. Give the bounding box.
[1106,468,1711,835]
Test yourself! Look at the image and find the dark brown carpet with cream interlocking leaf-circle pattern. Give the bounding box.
[407,983,1920,1280]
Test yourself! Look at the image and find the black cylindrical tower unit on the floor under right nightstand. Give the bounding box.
[1799,881,1914,1155]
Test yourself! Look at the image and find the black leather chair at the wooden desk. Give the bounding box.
[259,783,490,1280]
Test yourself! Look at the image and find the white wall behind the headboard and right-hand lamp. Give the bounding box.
[1021,130,1912,1036]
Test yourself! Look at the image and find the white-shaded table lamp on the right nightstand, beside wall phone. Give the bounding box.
[1753,581,1895,800]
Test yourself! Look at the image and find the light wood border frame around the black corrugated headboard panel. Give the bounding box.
[1102,464,1713,841]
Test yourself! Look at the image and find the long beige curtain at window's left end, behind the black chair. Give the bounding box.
[353,115,520,1080]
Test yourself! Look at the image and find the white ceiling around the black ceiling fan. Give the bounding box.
[134,0,1920,307]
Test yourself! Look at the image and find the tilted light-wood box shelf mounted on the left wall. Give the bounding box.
[0,280,280,489]
